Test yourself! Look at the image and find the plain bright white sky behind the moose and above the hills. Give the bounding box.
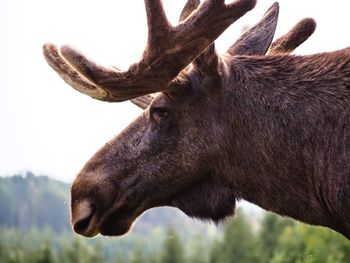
[0,0,350,184]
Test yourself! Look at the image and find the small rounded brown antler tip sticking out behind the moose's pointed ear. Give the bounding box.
[268,18,316,55]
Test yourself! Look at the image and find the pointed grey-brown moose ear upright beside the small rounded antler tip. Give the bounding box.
[227,2,279,56]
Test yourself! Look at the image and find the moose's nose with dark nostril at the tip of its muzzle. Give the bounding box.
[72,200,98,237]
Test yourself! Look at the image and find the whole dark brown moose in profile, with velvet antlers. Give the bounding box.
[43,0,350,239]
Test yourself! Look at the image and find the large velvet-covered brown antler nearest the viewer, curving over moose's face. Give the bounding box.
[43,0,256,101]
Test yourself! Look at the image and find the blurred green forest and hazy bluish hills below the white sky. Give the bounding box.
[0,172,350,263]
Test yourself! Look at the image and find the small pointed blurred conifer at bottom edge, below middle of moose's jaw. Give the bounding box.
[160,227,185,263]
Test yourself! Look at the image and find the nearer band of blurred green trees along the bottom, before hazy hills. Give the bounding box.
[0,211,350,263]
